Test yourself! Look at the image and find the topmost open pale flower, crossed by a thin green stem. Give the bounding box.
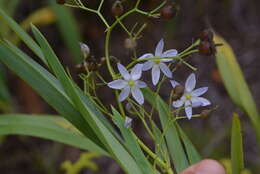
[139,39,178,85]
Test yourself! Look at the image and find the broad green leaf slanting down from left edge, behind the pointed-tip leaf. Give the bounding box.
[0,42,102,146]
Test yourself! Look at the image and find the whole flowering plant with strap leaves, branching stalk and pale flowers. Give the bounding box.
[0,0,252,174]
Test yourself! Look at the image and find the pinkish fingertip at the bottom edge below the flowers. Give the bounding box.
[181,159,226,174]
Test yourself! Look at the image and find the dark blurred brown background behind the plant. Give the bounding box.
[0,0,260,174]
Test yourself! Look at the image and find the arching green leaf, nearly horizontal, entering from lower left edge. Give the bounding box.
[0,114,109,156]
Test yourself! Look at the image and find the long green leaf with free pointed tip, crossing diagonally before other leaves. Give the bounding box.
[32,26,142,174]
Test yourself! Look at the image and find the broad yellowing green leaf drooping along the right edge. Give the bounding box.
[214,34,260,147]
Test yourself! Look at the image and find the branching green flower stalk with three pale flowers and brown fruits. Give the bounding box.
[58,0,216,173]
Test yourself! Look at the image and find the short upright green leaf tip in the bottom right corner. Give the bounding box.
[231,114,244,174]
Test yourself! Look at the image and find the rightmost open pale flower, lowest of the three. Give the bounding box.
[171,73,211,119]
